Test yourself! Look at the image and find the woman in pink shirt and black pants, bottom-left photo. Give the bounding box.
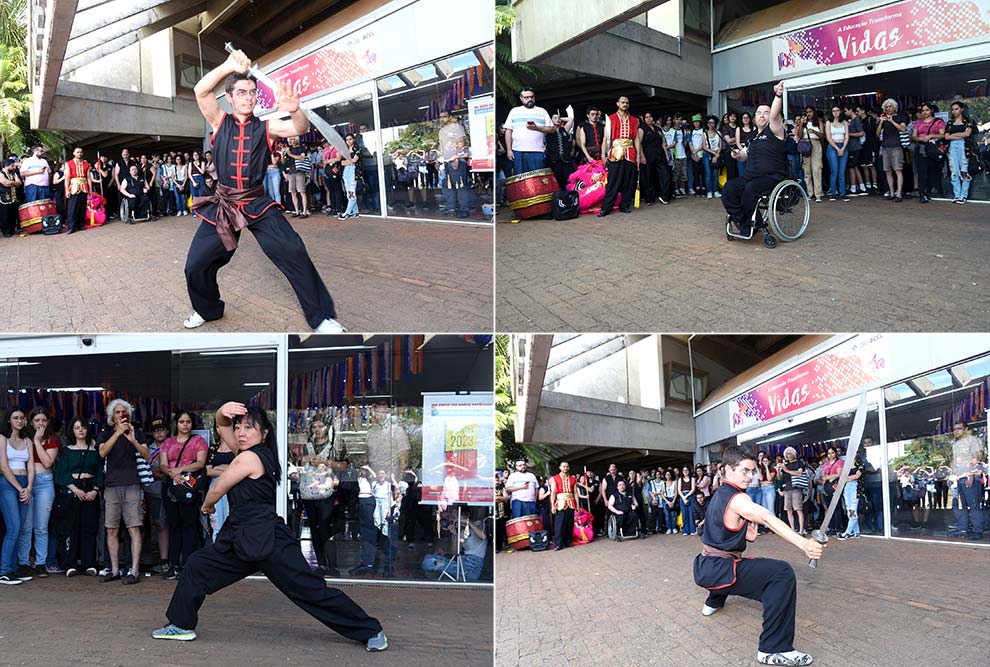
[159,410,210,579]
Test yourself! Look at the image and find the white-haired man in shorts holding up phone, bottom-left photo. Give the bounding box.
[96,398,151,584]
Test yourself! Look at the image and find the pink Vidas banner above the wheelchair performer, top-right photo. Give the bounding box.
[773,0,990,75]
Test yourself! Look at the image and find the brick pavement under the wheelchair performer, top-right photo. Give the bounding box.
[496,197,990,332]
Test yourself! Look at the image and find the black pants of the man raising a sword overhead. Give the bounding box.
[186,213,337,329]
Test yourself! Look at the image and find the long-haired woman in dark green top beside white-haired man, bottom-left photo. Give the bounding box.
[55,417,103,577]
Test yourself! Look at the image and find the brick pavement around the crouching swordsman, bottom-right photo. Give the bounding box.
[495,534,990,667]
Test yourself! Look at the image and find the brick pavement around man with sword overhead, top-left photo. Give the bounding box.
[0,215,493,333]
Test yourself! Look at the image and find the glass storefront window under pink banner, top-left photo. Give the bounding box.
[376,47,494,221]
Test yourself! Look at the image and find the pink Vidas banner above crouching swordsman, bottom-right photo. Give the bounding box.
[731,334,889,431]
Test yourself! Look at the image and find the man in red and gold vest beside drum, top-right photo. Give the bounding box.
[598,95,643,218]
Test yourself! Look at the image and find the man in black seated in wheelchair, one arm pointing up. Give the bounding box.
[722,81,787,236]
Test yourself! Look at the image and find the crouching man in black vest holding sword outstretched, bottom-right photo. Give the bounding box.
[694,446,824,665]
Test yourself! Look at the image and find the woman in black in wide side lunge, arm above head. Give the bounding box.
[151,402,388,651]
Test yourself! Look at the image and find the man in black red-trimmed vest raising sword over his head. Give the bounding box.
[183,51,346,333]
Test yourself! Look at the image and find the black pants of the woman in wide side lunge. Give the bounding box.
[165,524,382,643]
